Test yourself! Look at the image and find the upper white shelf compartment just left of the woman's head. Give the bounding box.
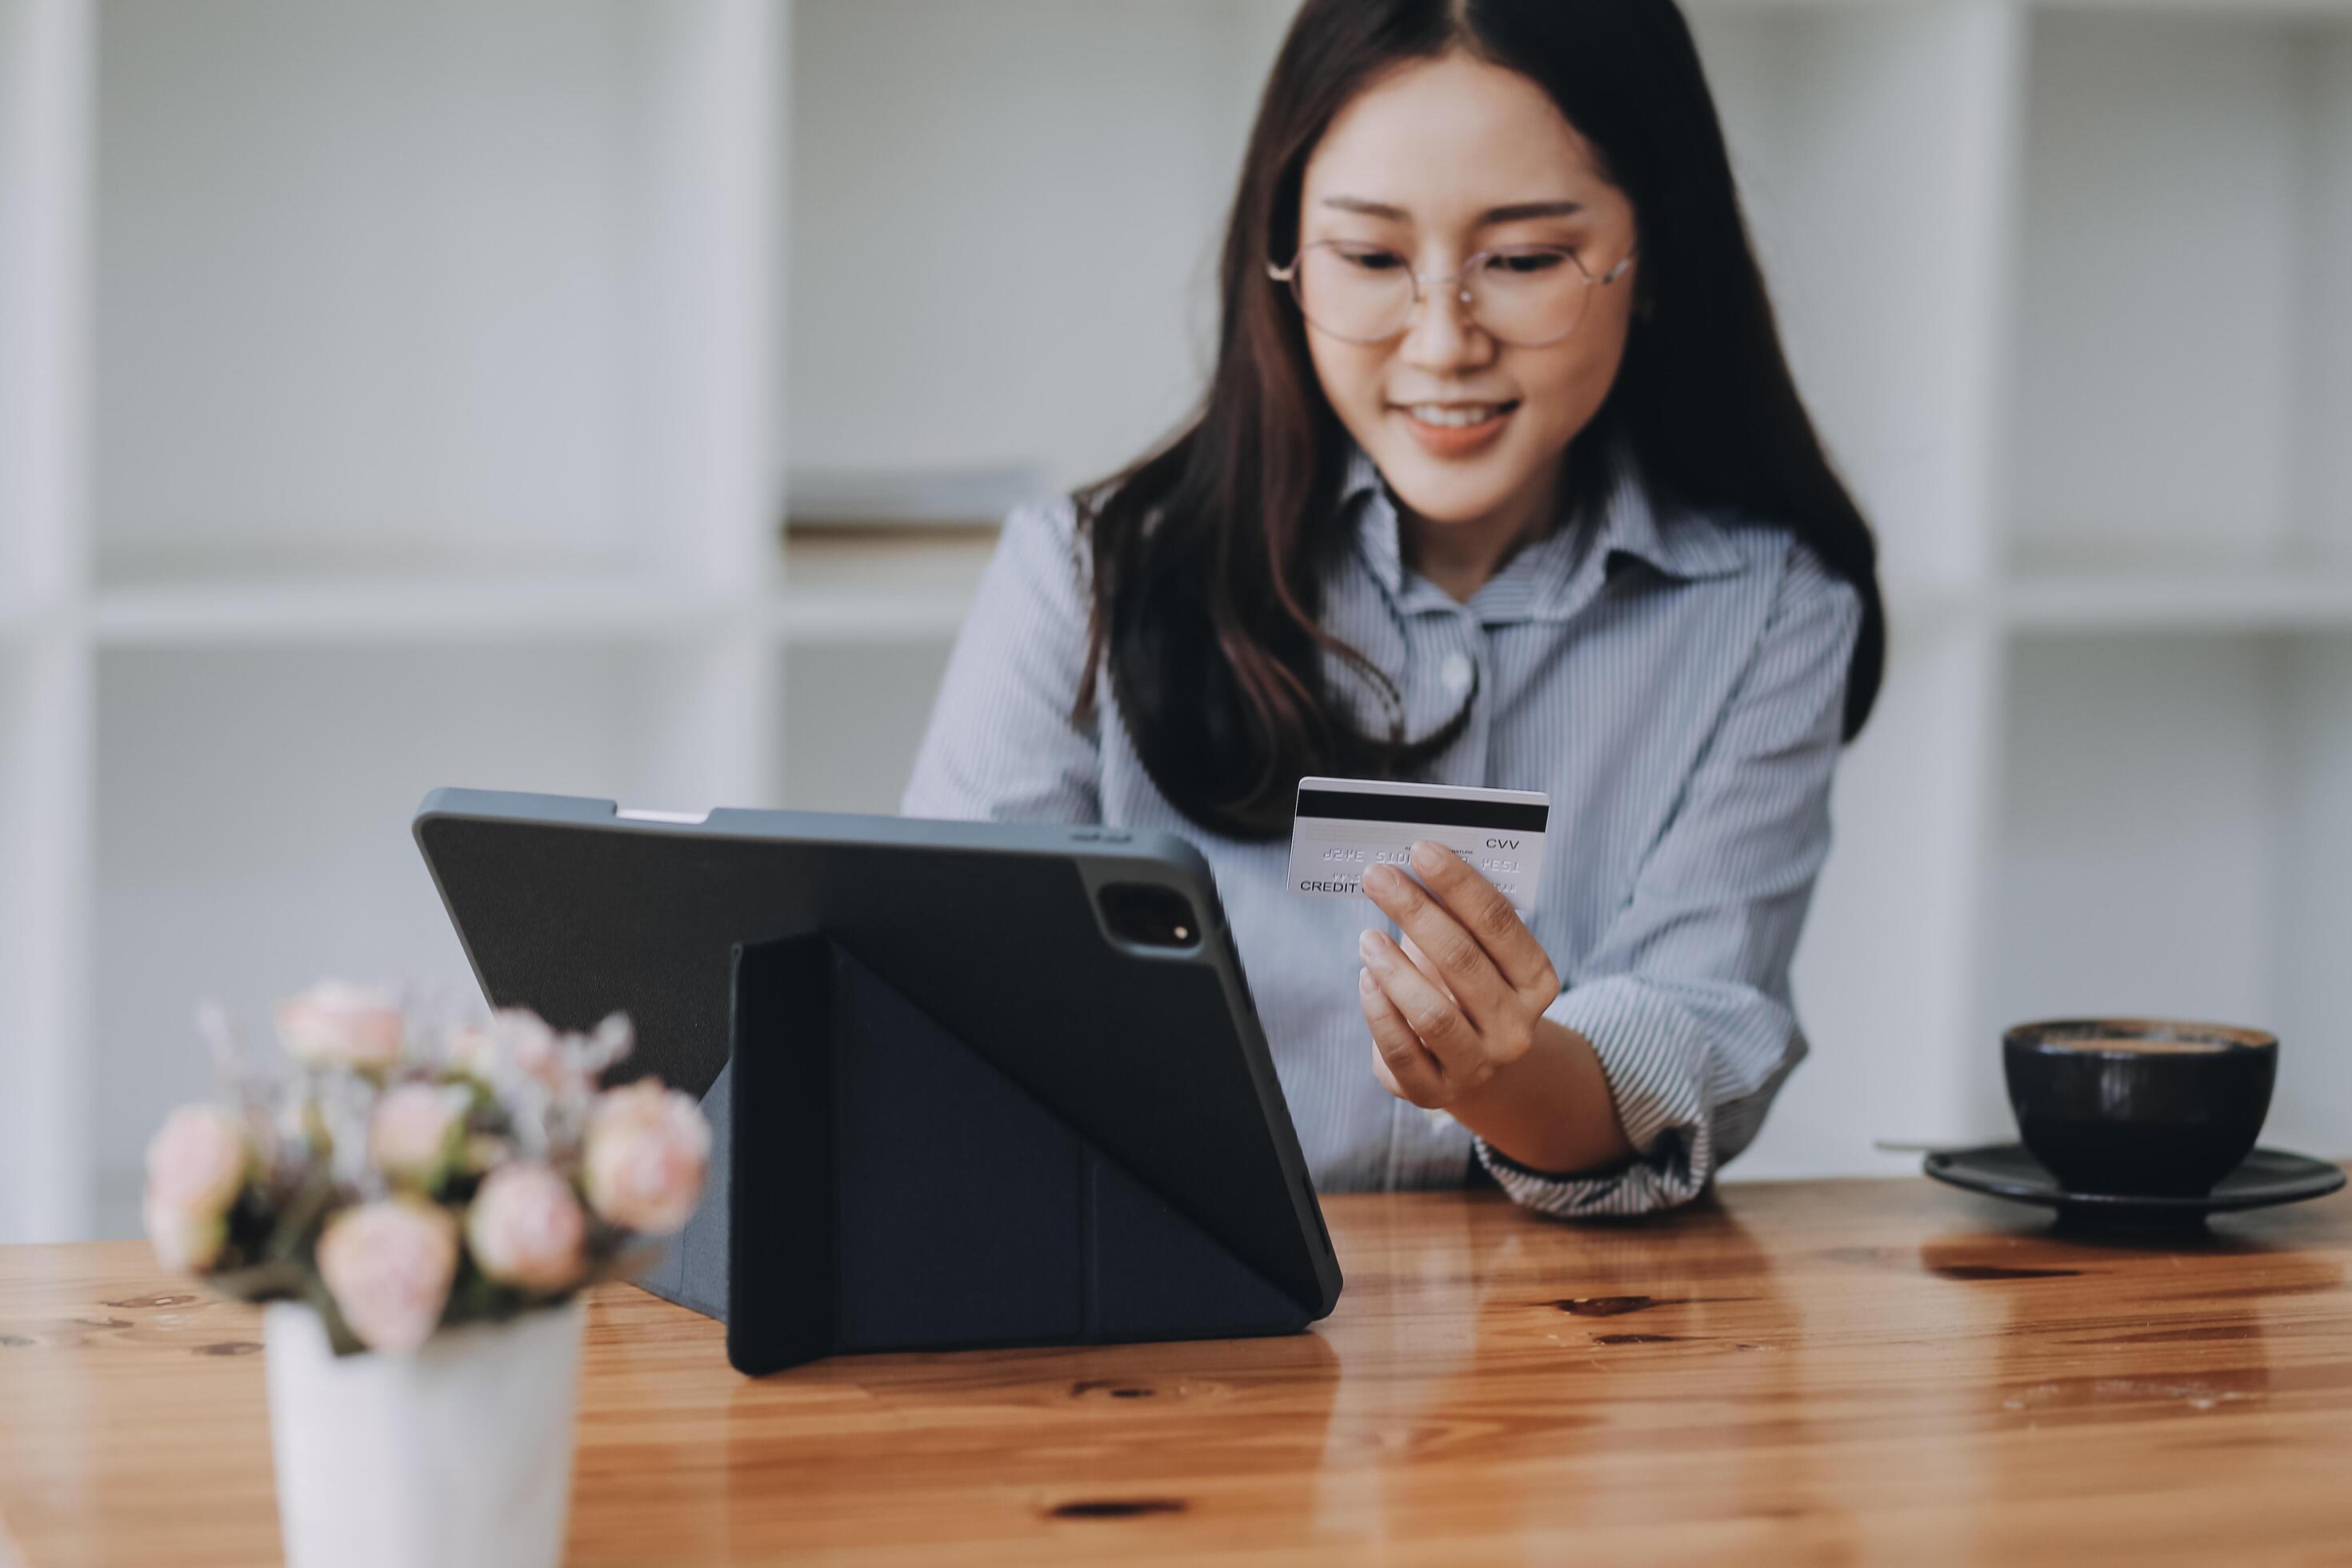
[783,0,1291,489]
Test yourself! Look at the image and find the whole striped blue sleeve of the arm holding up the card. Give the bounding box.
[1477,543,1861,1215]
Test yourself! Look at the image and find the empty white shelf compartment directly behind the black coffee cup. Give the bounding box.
[1985,632,2352,1154]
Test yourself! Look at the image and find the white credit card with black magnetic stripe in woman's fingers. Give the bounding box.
[1291,778,1552,914]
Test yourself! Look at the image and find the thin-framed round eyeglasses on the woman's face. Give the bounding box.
[1266,240,1632,348]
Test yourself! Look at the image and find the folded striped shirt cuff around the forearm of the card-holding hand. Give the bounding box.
[1472,975,1714,1218]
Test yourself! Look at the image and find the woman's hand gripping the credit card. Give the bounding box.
[1357,839,1559,1110]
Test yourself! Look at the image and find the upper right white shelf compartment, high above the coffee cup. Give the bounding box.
[2006,7,2352,571]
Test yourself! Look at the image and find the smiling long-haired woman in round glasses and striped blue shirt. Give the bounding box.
[903,0,1884,1215]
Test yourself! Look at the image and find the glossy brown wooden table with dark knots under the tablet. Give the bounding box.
[0,1180,2352,1566]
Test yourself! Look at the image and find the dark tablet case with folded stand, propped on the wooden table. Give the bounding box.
[414,790,1343,1370]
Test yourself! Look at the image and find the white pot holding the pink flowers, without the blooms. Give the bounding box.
[261,1295,588,1568]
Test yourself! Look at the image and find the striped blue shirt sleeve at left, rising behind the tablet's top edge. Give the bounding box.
[898,501,1103,822]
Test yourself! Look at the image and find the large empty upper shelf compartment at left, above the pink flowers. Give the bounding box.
[94,0,783,594]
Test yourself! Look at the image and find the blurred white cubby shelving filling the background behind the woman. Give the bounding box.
[0,0,2352,1242]
